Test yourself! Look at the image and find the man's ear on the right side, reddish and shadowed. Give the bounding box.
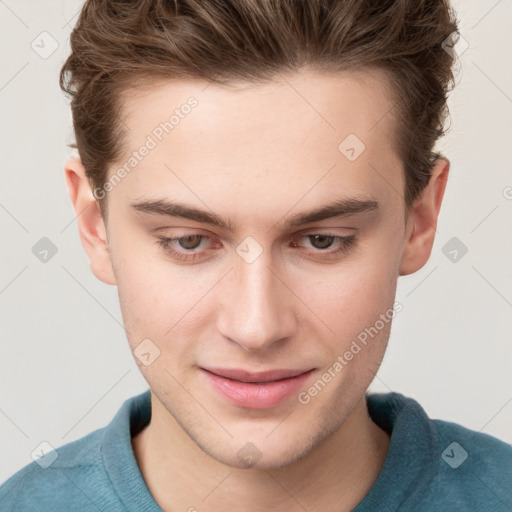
[400,156,450,276]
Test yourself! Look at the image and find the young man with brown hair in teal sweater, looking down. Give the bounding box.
[0,0,512,512]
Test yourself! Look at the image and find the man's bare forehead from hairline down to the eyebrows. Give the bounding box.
[109,70,402,218]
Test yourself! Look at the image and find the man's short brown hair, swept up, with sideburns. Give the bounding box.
[60,0,457,215]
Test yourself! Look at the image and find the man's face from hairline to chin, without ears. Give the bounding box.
[73,67,444,468]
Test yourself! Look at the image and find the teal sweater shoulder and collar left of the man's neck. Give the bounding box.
[0,390,152,512]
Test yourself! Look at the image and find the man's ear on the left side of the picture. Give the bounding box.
[64,157,116,285]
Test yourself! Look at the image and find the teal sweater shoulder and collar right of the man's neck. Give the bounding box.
[362,392,512,512]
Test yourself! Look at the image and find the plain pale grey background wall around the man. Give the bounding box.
[0,0,512,481]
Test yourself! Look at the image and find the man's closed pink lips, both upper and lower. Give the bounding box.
[200,368,314,409]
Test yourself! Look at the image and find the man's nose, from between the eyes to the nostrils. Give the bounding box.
[217,251,297,351]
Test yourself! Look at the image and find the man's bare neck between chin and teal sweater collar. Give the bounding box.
[132,394,389,512]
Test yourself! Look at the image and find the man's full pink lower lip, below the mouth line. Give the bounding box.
[201,370,313,409]
